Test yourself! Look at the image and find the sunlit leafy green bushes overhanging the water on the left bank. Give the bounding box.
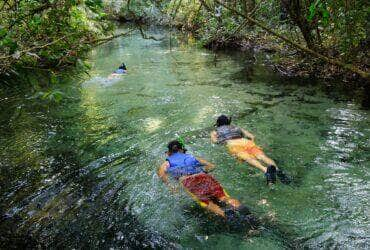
[0,0,111,74]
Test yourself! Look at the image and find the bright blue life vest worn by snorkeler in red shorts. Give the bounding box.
[166,152,204,178]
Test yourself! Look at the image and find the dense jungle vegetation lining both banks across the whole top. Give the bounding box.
[0,0,370,79]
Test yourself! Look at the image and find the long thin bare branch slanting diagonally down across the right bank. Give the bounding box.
[211,0,370,79]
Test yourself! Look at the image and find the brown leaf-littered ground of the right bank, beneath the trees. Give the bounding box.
[204,34,367,83]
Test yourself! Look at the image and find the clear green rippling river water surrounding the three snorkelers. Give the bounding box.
[0,26,370,249]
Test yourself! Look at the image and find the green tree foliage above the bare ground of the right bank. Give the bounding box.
[126,0,370,61]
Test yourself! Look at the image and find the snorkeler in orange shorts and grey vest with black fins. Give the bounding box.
[211,115,290,184]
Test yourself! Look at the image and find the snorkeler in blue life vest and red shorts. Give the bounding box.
[158,140,253,220]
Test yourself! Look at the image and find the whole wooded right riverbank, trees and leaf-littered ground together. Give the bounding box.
[105,1,370,94]
